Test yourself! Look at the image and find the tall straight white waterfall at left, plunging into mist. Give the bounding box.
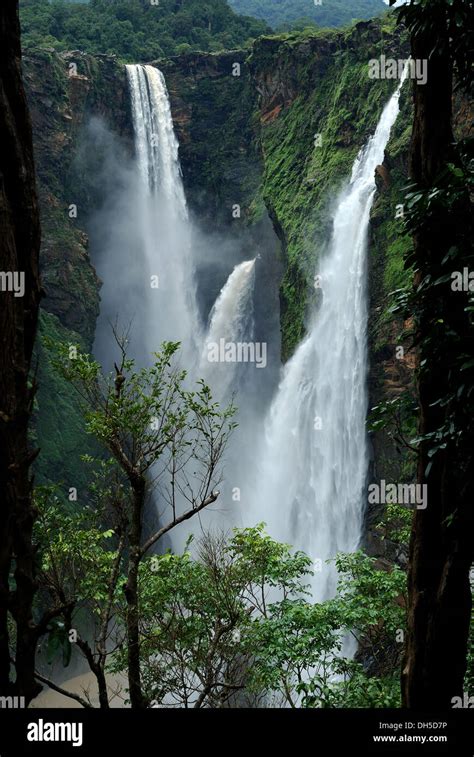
[127,65,202,368]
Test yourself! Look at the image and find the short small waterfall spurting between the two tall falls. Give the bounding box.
[200,260,255,402]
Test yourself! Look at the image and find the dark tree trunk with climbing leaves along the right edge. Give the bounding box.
[391,0,474,709]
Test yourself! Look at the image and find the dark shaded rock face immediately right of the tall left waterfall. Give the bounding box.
[156,50,263,229]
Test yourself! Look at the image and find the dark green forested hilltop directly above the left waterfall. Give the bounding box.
[20,0,268,62]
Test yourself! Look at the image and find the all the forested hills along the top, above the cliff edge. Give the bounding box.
[20,0,392,61]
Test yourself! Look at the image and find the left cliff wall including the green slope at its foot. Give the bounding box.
[24,50,131,491]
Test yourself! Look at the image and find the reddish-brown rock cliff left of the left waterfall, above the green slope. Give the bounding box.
[24,51,129,347]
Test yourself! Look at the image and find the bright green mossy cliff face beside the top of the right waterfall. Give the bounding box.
[251,22,408,359]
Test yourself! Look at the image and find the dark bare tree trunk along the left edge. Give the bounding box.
[0,0,41,702]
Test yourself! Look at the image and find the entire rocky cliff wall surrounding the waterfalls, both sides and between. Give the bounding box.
[25,21,412,496]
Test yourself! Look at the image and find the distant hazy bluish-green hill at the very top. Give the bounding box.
[229,0,387,28]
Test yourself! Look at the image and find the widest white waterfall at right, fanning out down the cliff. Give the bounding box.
[247,77,408,601]
